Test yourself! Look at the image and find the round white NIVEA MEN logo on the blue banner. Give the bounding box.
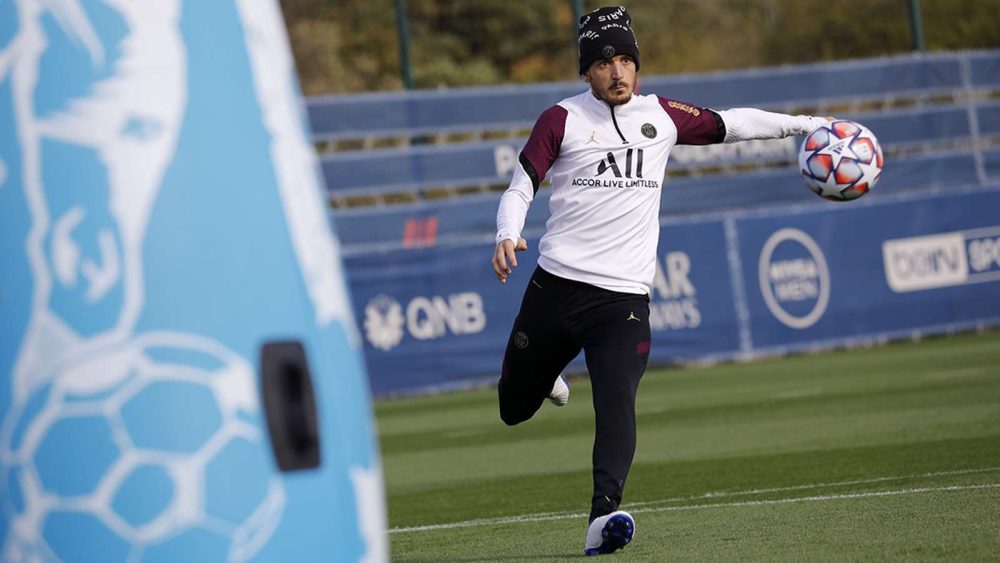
[758,229,830,329]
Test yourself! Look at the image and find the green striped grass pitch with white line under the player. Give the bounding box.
[375,331,1000,562]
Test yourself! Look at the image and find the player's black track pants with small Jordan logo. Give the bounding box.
[499,268,649,517]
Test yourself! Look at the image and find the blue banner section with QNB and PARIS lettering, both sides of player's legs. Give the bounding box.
[346,221,739,394]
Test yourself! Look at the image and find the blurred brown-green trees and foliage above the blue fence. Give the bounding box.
[282,0,1000,95]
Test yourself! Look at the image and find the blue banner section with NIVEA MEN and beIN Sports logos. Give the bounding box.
[737,190,1000,350]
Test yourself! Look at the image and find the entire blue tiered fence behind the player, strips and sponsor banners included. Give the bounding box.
[309,51,1000,394]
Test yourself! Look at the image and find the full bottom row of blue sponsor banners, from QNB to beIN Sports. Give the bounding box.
[346,186,1000,395]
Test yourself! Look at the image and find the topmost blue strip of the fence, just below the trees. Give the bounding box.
[307,51,1000,145]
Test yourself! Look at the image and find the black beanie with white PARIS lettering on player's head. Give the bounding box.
[578,6,639,74]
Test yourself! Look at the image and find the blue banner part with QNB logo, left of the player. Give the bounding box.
[346,243,538,394]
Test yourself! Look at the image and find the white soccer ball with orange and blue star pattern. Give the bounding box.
[799,120,883,201]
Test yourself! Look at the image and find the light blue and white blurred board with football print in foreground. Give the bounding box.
[0,0,388,561]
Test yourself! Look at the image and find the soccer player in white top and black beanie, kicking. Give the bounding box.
[493,7,827,555]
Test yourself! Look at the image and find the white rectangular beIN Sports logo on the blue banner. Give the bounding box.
[882,227,1000,293]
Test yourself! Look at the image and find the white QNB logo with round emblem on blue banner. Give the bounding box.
[364,291,486,351]
